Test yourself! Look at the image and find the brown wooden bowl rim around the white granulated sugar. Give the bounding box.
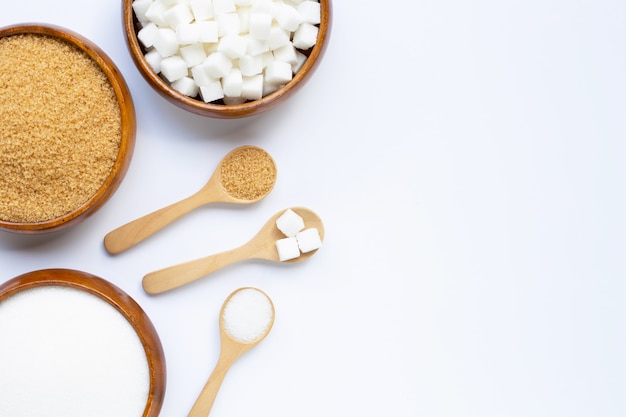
[0,269,166,417]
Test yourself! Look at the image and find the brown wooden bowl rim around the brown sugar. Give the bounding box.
[0,24,136,234]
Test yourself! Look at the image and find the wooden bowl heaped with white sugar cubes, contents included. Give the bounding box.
[123,0,331,118]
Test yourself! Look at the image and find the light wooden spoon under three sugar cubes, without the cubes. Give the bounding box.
[143,207,324,294]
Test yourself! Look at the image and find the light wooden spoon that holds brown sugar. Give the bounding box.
[104,146,276,254]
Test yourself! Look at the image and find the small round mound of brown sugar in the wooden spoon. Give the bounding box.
[220,147,276,200]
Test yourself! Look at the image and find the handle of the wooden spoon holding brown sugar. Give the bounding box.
[104,194,206,254]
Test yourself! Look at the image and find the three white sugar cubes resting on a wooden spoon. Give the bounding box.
[276,209,322,261]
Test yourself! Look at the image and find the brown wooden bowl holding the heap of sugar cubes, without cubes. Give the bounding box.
[123,0,331,119]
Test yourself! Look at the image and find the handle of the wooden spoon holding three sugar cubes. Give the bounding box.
[142,247,248,294]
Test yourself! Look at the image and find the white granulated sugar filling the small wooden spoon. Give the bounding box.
[222,288,274,343]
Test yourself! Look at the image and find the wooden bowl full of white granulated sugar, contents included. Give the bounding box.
[0,269,166,417]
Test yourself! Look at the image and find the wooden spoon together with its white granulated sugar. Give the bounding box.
[188,287,274,417]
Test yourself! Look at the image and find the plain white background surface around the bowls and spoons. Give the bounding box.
[0,0,626,417]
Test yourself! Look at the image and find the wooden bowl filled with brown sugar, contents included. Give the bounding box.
[0,24,136,234]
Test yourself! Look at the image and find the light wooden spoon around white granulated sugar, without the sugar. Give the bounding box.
[188,288,274,417]
